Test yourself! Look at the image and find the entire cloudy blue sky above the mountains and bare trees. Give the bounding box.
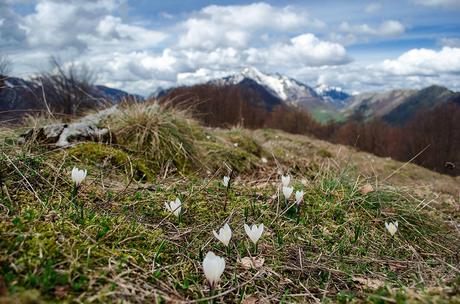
[0,0,460,95]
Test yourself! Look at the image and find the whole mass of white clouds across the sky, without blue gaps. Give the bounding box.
[4,0,460,95]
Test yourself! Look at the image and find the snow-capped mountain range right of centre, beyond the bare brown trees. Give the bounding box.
[182,68,460,124]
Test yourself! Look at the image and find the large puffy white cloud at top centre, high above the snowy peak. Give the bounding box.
[179,2,325,49]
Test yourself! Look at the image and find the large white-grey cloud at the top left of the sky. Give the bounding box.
[23,0,165,51]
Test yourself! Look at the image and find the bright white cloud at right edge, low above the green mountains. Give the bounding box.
[382,47,460,76]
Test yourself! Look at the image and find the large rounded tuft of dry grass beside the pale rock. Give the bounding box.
[104,102,203,171]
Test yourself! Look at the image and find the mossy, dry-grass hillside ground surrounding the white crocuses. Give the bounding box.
[0,118,460,303]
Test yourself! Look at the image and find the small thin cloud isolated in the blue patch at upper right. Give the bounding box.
[339,20,405,36]
